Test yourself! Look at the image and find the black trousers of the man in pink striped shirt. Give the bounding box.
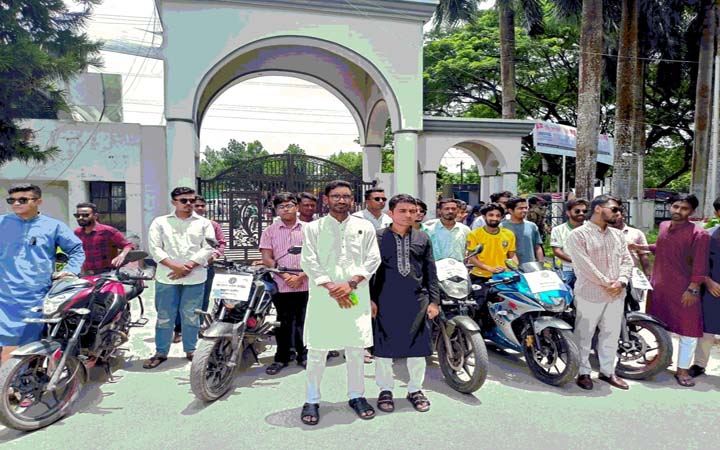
[272,291,308,364]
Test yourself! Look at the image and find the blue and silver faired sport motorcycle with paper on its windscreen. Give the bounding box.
[478,260,580,386]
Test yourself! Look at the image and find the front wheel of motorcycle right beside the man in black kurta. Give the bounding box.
[437,324,489,394]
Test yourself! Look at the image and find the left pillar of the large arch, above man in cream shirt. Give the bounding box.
[165,119,200,197]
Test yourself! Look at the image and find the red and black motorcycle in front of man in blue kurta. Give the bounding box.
[0,251,153,431]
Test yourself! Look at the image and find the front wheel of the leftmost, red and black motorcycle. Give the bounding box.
[0,355,82,431]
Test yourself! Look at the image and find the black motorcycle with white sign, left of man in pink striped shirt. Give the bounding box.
[190,244,301,402]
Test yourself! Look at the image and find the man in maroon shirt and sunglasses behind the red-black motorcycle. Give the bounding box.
[73,203,133,276]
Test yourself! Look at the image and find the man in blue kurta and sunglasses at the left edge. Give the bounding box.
[0,184,85,363]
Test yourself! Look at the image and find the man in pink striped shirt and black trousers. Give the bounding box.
[260,192,308,375]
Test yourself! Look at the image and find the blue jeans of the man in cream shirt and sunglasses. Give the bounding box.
[155,282,205,355]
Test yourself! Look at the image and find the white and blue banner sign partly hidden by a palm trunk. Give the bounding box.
[533,122,615,166]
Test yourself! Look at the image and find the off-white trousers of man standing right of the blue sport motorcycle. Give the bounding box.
[574,297,625,376]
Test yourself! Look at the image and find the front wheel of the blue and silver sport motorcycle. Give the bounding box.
[521,326,580,386]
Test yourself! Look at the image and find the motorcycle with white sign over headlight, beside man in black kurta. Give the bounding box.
[433,246,489,394]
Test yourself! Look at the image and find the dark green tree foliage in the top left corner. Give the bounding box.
[0,0,101,165]
